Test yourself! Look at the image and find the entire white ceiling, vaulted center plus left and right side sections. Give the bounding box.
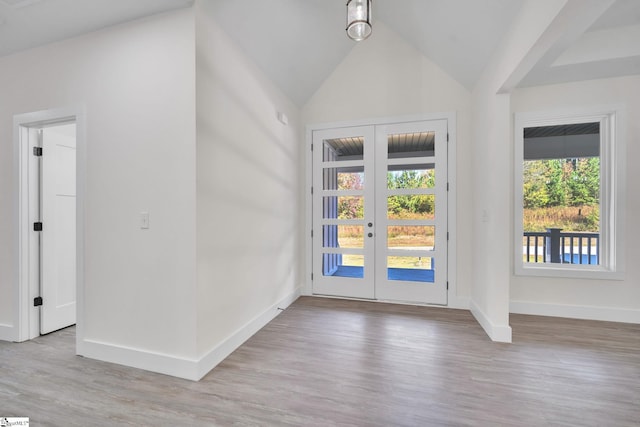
[0,0,640,105]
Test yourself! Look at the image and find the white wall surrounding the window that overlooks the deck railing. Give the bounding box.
[511,76,640,323]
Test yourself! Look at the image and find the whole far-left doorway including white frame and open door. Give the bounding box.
[14,109,83,342]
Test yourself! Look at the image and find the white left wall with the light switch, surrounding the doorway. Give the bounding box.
[0,10,196,359]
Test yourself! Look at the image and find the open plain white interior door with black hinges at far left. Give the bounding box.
[40,123,76,334]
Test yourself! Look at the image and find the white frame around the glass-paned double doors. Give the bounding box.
[302,112,458,308]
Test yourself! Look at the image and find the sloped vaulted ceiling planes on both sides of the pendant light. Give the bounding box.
[204,0,522,105]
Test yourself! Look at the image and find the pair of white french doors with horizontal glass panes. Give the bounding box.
[312,120,447,305]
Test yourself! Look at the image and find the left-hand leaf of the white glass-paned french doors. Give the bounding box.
[312,126,375,299]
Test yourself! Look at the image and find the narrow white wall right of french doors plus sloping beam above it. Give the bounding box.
[471,0,563,342]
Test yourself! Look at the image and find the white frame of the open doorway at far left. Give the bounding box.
[13,106,86,354]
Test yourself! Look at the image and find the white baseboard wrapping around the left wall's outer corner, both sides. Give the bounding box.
[77,288,300,381]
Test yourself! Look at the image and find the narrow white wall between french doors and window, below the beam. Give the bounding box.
[471,89,512,342]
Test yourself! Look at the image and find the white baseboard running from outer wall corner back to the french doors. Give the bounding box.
[197,288,301,380]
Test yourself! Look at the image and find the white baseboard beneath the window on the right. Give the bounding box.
[509,301,640,323]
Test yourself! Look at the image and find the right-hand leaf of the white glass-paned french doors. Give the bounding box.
[375,120,447,305]
